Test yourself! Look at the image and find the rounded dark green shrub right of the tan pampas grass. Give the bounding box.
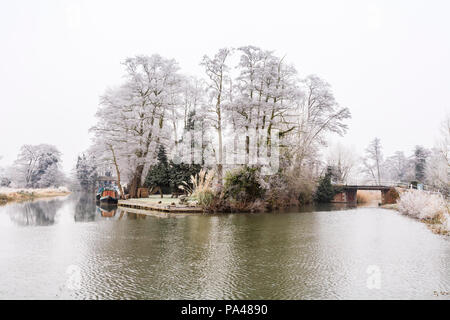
[224,166,264,203]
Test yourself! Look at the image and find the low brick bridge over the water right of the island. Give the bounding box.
[332,185,398,204]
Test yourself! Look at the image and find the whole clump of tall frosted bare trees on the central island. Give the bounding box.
[90,46,350,197]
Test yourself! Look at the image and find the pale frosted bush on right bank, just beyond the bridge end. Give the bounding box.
[398,190,448,219]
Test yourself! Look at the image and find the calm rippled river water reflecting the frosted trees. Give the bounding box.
[0,194,450,299]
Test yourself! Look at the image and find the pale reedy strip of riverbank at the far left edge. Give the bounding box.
[0,187,70,205]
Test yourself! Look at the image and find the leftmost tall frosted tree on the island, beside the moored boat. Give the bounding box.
[93,55,180,197]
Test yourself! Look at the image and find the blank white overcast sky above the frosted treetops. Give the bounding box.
[0,0,450,172]
